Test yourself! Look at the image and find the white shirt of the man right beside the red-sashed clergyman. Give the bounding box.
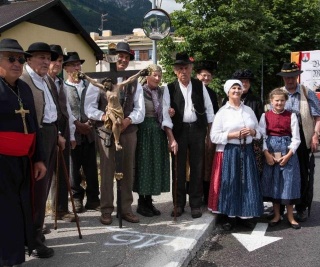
[26,64,58,123]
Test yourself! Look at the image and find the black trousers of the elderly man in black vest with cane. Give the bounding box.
[172,123,206,208]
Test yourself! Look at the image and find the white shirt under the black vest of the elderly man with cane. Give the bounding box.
[162,81,214,129]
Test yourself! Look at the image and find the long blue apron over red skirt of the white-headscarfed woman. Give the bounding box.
[218,144,263,217]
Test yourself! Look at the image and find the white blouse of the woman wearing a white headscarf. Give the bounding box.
[210,102,261,151]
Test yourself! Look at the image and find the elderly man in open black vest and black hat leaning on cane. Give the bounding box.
[162,53,214,218]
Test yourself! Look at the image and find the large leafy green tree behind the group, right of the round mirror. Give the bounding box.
[159,0,320,102]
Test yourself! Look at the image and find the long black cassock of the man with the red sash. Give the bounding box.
[0,78,42,266]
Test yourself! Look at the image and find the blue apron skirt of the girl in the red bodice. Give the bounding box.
[262,136,301,205]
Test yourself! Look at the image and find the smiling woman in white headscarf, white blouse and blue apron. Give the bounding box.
[208,80,263,230]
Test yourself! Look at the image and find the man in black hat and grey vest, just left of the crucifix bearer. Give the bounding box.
[63,52,100,215]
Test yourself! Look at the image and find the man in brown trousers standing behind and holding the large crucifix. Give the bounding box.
[85,42,145,225]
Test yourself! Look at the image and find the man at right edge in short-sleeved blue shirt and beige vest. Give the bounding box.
[277,62,320,222]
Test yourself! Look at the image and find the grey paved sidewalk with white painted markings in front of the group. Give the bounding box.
[23,193,215,267]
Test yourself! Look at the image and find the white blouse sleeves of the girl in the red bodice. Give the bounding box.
[259,113,301,153]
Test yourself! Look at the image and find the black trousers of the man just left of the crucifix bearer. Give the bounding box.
[70,138,99,202]
